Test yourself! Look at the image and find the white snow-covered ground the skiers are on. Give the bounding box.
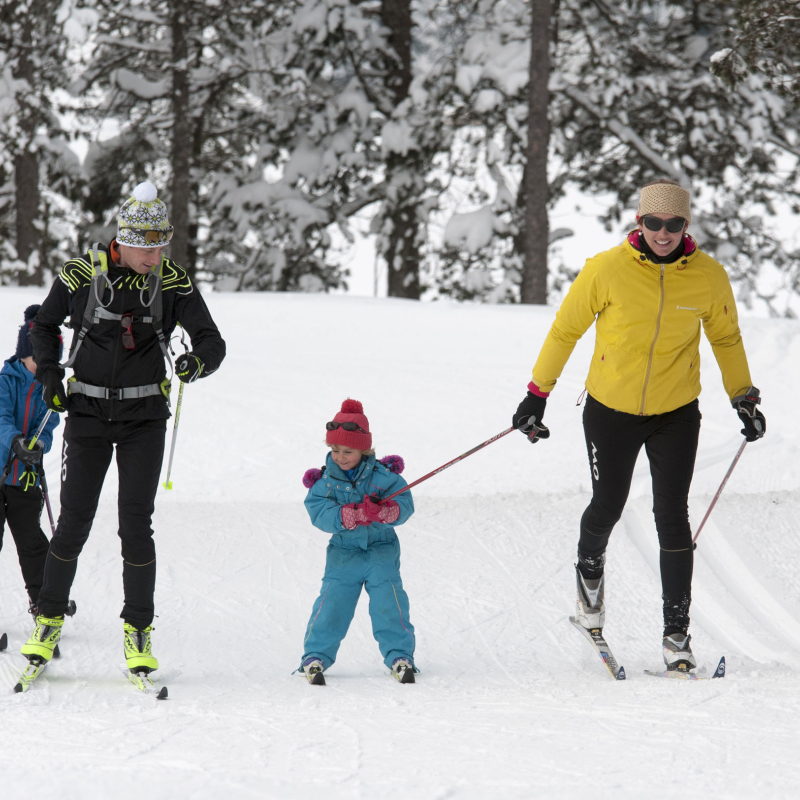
[0,288,800,800]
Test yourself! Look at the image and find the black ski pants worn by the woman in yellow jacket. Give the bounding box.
[578,395,700,635]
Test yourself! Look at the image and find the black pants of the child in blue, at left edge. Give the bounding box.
[0,484,50,603]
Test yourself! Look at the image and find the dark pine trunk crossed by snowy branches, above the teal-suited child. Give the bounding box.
[381,0,421,300]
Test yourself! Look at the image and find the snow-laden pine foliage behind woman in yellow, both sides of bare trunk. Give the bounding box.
[432,0,800,313]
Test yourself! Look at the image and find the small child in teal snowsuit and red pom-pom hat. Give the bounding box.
[301,400,415,684]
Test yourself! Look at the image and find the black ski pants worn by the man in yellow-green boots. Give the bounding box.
[39,414,167,629]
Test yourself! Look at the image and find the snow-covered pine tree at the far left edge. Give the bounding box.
[0,0,88,285]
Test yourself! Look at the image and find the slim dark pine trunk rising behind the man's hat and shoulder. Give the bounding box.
[169,0,195,277]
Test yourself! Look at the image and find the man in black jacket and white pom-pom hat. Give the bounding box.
[22,183,225,673]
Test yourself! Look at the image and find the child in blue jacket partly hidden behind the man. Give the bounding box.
[0,305,58,609]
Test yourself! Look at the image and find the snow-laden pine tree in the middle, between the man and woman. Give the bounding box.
[205,0,450,297]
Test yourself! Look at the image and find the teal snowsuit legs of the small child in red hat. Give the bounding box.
[300,532,415,669]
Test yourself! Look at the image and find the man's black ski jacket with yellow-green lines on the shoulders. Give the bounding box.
[31,242,225,421]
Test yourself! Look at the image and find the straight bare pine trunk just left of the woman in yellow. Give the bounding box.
[521,0,551,305]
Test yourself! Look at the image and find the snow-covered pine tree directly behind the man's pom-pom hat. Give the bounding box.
[79,0,278,272]
